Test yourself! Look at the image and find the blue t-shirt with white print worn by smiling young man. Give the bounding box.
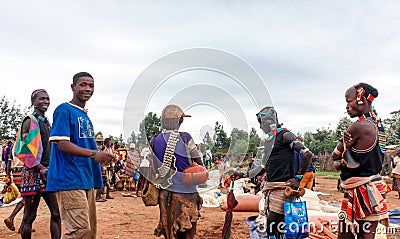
[47,103,103,191]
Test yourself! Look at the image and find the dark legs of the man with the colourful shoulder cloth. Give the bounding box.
[21,192,61,239]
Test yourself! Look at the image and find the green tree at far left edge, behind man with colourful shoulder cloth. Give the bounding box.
[0,96,28,139]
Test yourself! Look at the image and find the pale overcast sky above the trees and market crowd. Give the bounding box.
[0,0,400,143]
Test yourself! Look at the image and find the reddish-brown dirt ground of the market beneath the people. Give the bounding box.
[0,177,400,239]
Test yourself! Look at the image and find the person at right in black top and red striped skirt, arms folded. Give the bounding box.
[332,83,388,239]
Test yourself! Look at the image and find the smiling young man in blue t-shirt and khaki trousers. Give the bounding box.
[47,72,113,239]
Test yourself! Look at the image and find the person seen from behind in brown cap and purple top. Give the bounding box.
[150,105,203,239]
